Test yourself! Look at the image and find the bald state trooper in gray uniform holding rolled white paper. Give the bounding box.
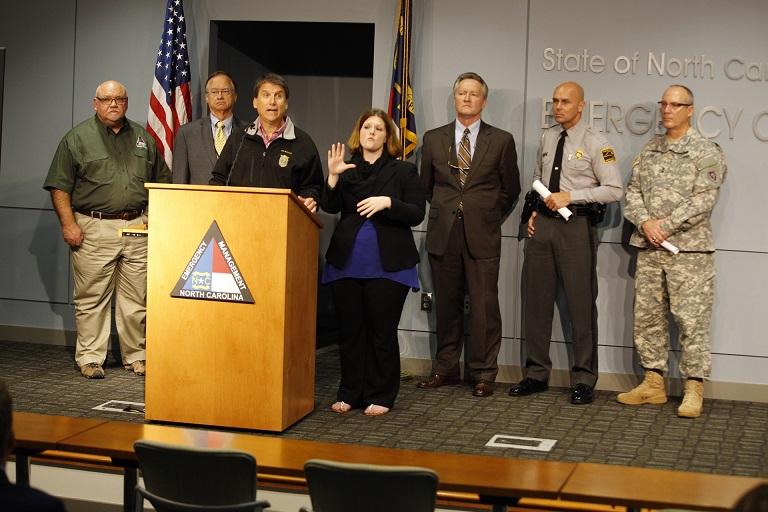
[509,82,623,404]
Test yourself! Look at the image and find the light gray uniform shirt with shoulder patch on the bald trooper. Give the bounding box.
[533,122,624,204]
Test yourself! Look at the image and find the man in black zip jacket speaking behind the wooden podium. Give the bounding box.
[210,73,323,212]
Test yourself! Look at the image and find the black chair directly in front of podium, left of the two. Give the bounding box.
[133,441,269,512]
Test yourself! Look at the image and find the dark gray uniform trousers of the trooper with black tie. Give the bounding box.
[523,215,597,386]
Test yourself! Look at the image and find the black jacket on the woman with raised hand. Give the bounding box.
[320,158,426,271]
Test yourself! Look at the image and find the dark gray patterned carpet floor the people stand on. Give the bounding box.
[0,342,768,477]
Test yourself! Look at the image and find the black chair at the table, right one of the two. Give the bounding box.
[301,459,437,512]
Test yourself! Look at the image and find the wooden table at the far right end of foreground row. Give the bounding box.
[560,462,768,510]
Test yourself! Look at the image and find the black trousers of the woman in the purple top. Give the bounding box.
[331,279,408,408]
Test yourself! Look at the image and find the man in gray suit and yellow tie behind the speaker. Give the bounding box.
[172,71,248,185]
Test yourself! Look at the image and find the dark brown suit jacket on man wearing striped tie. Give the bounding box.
[421,122,520,258]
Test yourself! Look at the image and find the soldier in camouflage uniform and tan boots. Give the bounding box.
[617,85,726,418]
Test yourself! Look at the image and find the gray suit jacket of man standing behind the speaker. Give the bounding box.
[171,114,248,185]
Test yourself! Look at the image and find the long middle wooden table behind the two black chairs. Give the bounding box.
[59,422,576,510]
